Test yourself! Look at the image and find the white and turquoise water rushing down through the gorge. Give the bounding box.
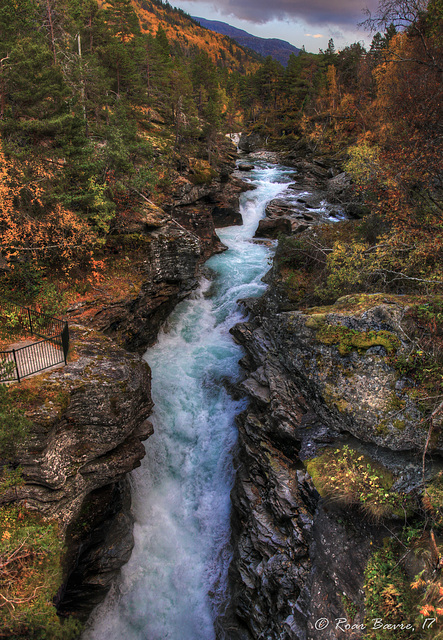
[83,161,293,640]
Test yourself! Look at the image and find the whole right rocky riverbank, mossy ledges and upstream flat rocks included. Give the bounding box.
[229,140,443,640]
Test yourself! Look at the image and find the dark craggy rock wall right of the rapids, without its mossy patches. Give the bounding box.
[230,284,436,640]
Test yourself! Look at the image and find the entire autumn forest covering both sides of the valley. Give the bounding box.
[0,0,443,310]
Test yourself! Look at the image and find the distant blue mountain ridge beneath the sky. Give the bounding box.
[192,16,300,66]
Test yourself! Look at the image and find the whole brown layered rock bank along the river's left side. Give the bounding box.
[2,144,253,620]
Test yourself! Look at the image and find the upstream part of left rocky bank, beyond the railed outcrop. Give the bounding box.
[69,141,250,353]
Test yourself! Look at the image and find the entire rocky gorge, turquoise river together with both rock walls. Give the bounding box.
[10,148,443,640]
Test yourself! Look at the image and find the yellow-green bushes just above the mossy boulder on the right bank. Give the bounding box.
[276,215,443,308]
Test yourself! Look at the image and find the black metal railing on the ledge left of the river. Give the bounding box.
[0,300,69,382]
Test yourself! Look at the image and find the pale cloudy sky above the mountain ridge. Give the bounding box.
[169,0,378,53]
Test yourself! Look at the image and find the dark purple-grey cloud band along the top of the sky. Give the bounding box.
[189,0,378,26]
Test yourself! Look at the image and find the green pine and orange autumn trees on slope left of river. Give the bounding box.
[0,0,250,296]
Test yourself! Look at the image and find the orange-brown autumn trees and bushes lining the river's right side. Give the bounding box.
[240,0,443,301]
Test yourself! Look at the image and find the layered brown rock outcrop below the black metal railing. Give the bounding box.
[9,327,153,619]
